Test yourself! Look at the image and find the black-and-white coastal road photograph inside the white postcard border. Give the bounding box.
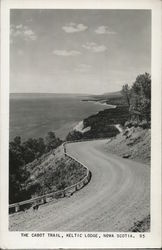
[0,0,160,247]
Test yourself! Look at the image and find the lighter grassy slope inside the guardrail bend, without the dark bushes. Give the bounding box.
[25,146,86,199]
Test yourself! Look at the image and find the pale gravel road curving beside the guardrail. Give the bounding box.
[10,140,150,232]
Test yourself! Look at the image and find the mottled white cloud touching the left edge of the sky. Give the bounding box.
[10,24,37,43]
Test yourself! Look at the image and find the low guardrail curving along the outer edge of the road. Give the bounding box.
[9,142,91,213]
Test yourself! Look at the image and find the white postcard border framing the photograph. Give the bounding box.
[0,0,161,249]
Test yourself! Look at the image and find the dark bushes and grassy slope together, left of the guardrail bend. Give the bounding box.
[9,132,86,204]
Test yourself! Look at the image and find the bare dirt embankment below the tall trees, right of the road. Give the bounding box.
[105,127,151,164]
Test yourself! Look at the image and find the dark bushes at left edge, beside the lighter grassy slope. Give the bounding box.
[9,132,61,203]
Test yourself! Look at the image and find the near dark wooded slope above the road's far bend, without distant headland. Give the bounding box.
[67,106,129,140]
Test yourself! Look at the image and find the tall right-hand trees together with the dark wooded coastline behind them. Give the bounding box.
[66,73,151,140]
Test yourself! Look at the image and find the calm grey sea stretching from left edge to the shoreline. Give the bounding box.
[10,94,108,140]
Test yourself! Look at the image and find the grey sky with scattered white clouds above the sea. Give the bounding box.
[10,9,151,94]
